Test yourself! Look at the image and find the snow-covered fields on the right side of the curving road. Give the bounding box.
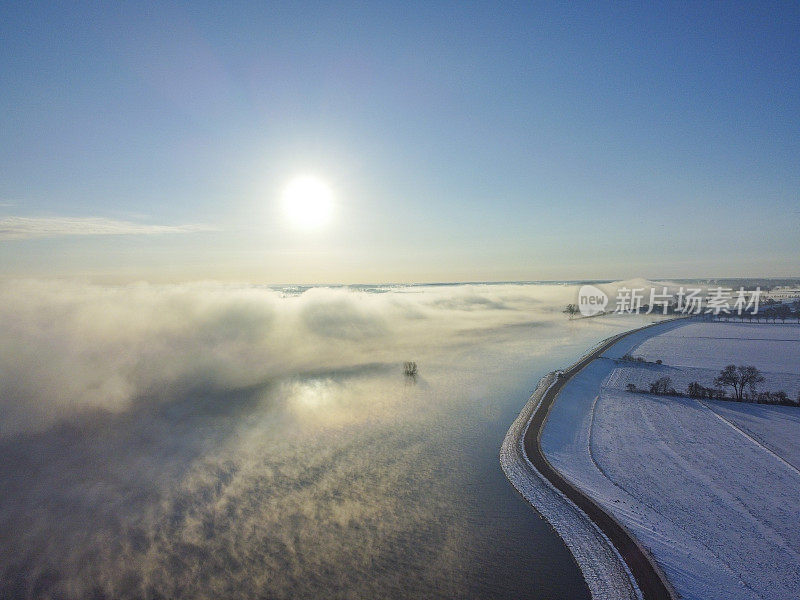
[542,322,800,600]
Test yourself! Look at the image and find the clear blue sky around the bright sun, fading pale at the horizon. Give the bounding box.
[0,2,800,283]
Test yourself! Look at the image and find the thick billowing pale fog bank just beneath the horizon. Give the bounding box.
[0,281,569,435]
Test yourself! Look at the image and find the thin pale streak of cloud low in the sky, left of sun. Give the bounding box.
[0,217,213,240]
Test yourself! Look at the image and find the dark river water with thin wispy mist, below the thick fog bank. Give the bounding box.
[0,286,652,599]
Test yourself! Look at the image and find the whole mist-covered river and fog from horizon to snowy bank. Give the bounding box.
[0,281,656,598]
